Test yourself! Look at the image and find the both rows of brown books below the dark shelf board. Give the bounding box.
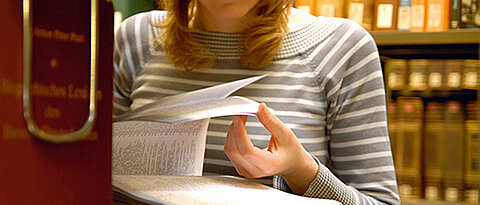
[385,59,480,204]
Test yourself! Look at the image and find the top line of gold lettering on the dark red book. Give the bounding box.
[33,27,86,43]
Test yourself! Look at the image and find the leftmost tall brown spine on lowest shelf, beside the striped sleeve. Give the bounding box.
[396,97,423,199]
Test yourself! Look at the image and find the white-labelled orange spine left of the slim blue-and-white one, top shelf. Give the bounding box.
[373,0,398,30]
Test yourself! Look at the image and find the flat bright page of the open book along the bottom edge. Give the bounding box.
[112,175,340,205]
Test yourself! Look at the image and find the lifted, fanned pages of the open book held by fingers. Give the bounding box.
[114,75,265,123]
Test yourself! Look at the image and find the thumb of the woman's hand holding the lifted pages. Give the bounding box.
[257,103,293,143]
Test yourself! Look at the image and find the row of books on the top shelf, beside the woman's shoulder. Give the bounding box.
[295,0,480,32]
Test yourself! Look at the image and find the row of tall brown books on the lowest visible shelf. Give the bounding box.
[388,97,480,204]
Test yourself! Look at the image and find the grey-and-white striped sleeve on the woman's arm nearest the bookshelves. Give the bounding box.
[274,21,400,204]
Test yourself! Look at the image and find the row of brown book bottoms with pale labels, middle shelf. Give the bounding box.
[384,59,480,91]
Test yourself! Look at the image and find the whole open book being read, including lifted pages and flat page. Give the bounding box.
[112,76,340,204]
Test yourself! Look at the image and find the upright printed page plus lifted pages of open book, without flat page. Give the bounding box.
[113,76,265,176]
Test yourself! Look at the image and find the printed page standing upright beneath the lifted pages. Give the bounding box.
[112,119,209,175]
